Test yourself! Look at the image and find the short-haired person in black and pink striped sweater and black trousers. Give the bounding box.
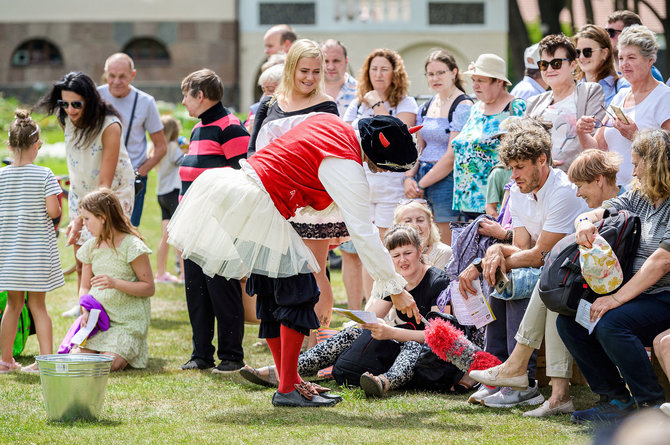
[179,69,249,373]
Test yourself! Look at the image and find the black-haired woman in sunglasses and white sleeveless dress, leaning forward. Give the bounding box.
[37,72,135,288]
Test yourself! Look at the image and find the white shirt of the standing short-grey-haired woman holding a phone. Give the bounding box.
[604,83,670,185]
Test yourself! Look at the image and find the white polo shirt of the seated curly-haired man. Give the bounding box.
[510,168,589,241]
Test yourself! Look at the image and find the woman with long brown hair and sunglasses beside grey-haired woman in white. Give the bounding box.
[572,25,630,106]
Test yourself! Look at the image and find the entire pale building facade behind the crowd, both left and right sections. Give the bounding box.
[0,0,507,111]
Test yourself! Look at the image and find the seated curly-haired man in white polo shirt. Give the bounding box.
[459,118,587,407]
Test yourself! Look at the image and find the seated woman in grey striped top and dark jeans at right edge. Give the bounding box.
[556,129,670,423]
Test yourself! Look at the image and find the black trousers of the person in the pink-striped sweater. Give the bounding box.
[184,259,244,364]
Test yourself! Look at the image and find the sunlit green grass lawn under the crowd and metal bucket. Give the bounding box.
[0,155,595,444]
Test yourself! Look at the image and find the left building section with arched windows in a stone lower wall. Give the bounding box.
[0,0,238,103]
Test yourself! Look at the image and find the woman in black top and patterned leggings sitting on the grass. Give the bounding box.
[240,224,480,397]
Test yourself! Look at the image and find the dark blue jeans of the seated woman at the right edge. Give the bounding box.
[556,292,670,403]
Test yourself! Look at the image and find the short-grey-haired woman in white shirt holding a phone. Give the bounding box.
[577,25,670,185]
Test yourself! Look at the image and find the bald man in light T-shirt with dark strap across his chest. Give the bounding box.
[98,53,167,227]
